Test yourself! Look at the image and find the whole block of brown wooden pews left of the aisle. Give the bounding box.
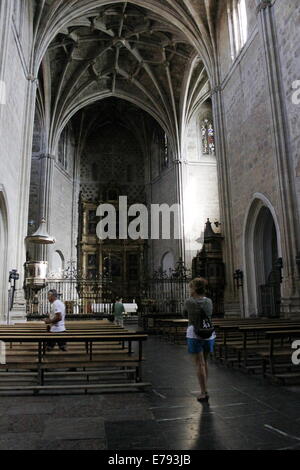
[0,320,150,393]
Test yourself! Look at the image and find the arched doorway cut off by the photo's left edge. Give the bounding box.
[0,191,8,320]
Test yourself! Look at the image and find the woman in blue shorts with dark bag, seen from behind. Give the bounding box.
[184,278,216,402]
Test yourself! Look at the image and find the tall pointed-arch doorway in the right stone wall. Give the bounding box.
[245,199,282,318]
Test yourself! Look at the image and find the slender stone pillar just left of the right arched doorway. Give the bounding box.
[212,86,242,317]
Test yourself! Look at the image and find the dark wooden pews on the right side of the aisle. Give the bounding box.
[144,316,300,382]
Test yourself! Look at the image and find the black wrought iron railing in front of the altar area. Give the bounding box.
[26,260,191,317]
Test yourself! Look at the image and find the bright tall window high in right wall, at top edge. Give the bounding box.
[228,0,248,60]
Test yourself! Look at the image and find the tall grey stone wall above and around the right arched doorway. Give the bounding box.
[218,0,300,316]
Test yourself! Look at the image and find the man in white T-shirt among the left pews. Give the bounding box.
[45,289,67,352]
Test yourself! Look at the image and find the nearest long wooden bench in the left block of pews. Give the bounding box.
[0,327,149,391]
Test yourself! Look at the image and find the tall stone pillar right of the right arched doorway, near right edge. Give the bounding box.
[256,0,300,317]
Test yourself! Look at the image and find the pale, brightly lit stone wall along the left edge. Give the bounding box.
[0,0,32,320]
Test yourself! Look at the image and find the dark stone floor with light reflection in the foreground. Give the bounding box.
[0,338,300,450]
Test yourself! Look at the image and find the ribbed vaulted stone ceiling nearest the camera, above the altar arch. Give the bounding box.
[36,0,219,157]
